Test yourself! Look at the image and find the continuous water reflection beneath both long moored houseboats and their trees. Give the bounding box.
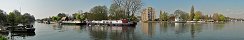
[53,25,136,40]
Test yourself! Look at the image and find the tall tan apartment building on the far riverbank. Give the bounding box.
[141,7,156,21]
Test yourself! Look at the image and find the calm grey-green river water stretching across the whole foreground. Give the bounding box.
[5,22,244,40]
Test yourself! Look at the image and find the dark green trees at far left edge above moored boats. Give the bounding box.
[0,10,35,26]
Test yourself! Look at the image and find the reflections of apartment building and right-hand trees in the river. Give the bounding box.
[141,22,225,40]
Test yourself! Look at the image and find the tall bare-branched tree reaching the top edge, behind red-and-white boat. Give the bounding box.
[113,0,142,18]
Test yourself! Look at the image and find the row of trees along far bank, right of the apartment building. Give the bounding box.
[159,6,231,21]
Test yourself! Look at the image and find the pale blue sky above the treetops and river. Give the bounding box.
[0,0,244,19]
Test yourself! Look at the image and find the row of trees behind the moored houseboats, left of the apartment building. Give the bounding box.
[44,0,142,21]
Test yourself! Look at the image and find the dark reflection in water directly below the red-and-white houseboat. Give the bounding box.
[88,26,136,40]
